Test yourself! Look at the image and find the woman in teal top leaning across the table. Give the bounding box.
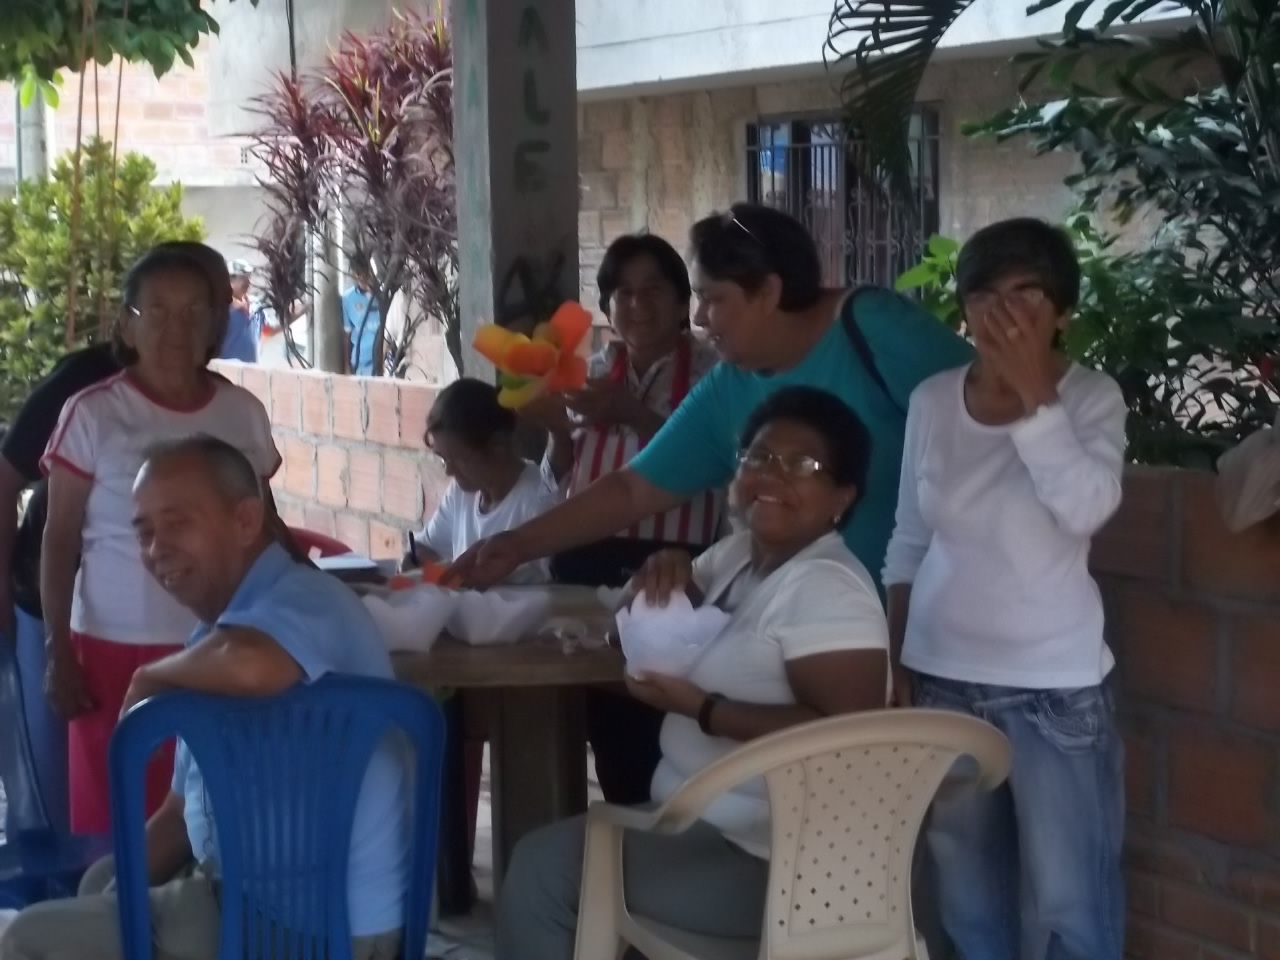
[453,204,973,586]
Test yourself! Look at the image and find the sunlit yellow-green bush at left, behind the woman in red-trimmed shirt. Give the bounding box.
[0,140,204,419]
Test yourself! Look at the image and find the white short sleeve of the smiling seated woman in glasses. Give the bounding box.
[760,559,888,660]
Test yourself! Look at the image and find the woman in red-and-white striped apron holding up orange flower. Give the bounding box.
[527,233,724,804]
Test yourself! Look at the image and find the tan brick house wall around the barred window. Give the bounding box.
[579,58,1167,304]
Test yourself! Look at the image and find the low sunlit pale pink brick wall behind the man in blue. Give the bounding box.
[218,364,445,559]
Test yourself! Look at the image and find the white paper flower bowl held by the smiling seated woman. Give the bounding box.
[617,593,730,677]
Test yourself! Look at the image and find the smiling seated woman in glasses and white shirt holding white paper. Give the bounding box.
[497,387,888,960]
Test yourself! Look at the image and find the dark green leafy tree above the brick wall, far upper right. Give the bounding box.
[969,0,1280,462]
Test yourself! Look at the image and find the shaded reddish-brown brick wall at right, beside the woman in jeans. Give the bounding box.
[1094,470,1280,960]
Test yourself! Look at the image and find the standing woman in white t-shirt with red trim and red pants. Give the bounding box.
[40,242,283,833]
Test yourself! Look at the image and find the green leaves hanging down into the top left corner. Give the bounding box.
[0,0,259,94]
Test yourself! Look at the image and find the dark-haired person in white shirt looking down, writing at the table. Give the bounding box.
[402,378,562,584]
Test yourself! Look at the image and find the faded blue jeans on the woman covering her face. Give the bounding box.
[915,675,1125,960]
